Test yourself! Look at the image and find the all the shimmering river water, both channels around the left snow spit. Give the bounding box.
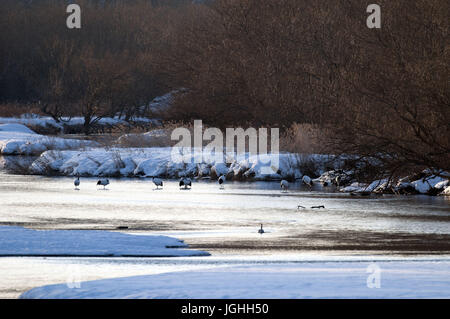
[0,172,450,298]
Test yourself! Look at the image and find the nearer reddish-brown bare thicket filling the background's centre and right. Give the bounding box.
[160,0,450,179]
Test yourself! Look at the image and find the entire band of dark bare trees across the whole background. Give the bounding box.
[0,0,450,176]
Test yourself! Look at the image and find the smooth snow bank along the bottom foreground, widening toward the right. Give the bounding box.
[21,261,450,299]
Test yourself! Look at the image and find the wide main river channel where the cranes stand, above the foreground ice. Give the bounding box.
[0,174,450,255]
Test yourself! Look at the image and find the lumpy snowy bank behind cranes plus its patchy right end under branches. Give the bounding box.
[25,147,450,195]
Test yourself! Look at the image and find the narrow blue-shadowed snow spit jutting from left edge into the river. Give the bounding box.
[0,225,209,257]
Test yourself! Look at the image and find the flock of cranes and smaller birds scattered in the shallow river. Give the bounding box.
[73,175,326,235]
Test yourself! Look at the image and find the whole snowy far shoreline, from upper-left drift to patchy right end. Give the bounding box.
[0,124,450,195]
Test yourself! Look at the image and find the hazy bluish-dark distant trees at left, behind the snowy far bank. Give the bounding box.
[0,0,180,134]
